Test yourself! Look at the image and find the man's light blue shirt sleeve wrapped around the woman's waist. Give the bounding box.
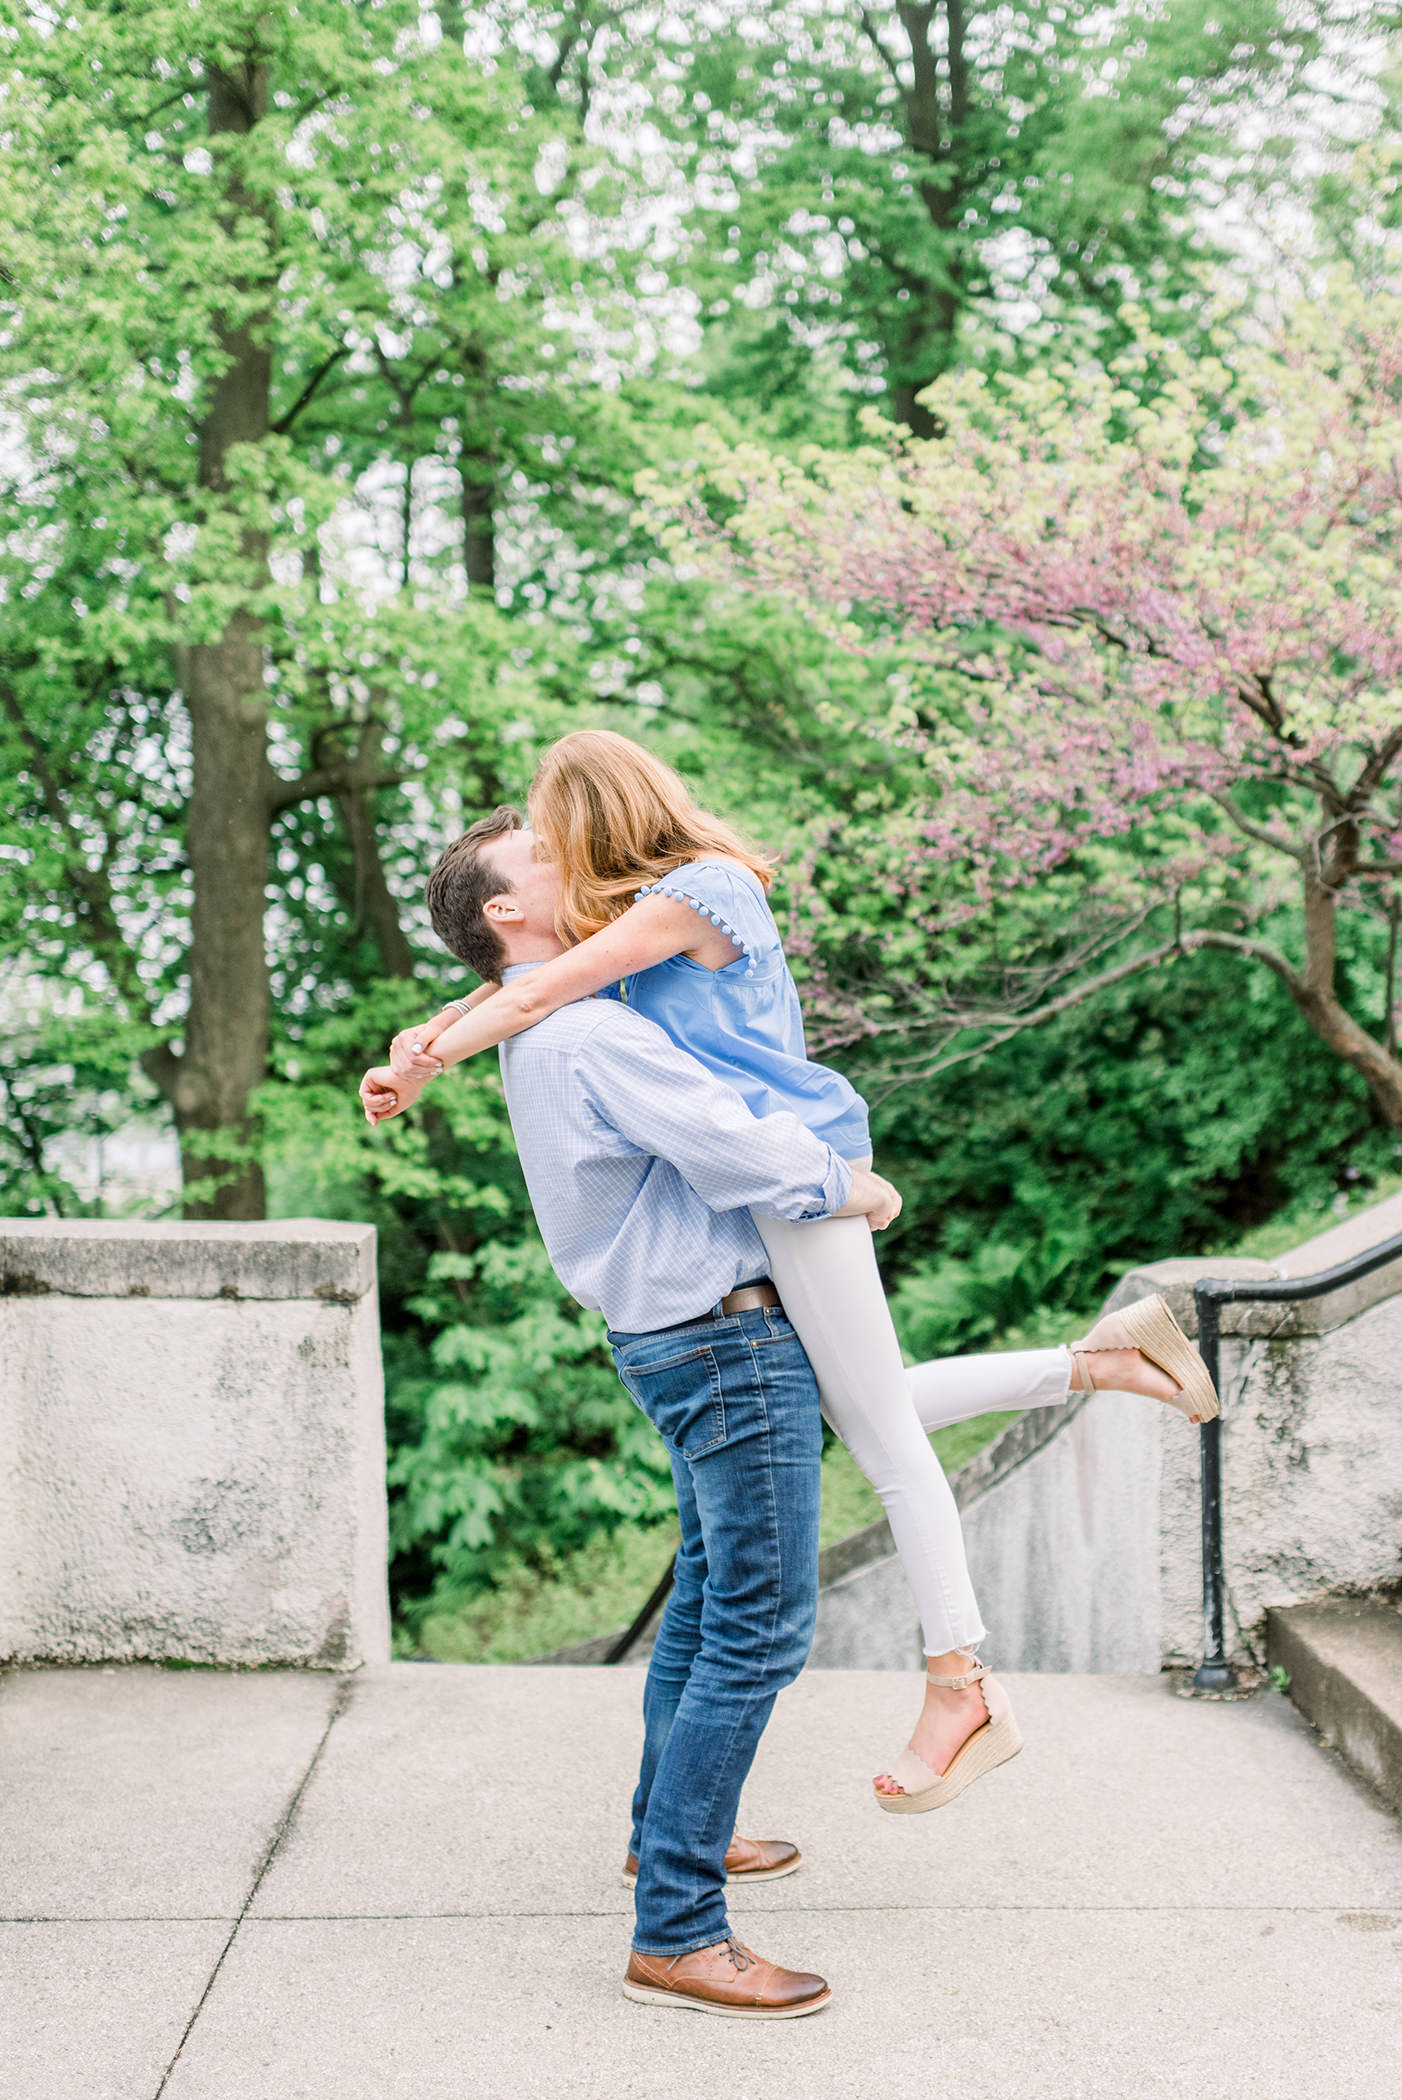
[575,1012,856,1220]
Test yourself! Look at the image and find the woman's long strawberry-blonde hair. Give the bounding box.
[529,729,774,941]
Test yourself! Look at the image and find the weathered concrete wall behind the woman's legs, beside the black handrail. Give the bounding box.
[812,1197,1402,1672]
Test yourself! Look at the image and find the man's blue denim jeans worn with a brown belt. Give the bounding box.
[609,1306,823,1955]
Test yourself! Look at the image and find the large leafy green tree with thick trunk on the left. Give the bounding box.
[0,0,663,1216]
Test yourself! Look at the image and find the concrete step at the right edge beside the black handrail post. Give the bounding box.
[1266,1602,1402,1810]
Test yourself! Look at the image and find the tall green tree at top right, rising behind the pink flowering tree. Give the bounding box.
[670,0,1381,426]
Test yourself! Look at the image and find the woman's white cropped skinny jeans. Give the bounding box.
[753,1201,1070,1655]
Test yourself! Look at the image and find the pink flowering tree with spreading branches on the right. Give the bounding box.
[644,277,1402,1130]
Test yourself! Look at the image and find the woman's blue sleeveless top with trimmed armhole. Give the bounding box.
[625,861,871,1159]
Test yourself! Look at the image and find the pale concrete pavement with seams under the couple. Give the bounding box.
[0,1663,1402,2100]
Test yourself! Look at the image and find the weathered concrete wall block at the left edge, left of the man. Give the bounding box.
[0,1218,388,1665]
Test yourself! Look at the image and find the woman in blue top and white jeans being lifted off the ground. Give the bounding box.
[371,729,1217,1814]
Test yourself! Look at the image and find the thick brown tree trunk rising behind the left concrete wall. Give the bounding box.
[174,61,271,1218]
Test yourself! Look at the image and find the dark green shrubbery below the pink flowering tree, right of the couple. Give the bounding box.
[868,926,1398,1357]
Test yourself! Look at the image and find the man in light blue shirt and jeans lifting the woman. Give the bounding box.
[361,809,898,2020]
